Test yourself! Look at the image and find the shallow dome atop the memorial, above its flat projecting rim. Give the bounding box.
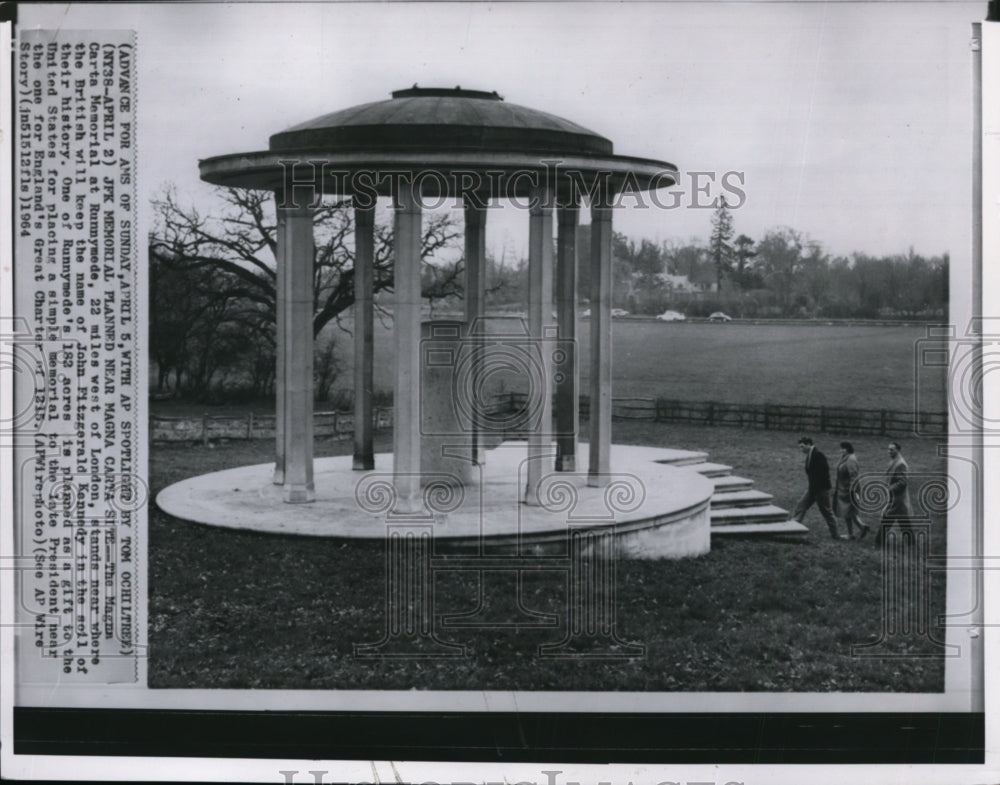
[269,85,614,156]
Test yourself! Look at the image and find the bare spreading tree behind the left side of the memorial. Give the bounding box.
[149,187,464,395]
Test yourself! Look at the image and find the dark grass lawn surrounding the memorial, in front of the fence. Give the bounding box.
[149,422,945,692]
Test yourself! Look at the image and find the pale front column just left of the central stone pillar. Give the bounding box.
[392,180,421,512]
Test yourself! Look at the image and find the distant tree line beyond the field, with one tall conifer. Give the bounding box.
[494,202,949,320]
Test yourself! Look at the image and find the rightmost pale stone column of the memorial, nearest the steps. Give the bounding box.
[587,187,611,487]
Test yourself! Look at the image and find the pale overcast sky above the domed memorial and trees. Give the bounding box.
[20,0,986,260]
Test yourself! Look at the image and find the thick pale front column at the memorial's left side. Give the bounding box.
[276,196,315,503]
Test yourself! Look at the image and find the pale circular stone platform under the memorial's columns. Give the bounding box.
[156,442,714,558]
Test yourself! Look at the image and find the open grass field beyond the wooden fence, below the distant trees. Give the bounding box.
[152,319,946,415]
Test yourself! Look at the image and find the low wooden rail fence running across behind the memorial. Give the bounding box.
[149,392,948,443]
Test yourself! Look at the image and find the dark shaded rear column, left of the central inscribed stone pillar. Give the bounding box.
[354,205,375,471]
